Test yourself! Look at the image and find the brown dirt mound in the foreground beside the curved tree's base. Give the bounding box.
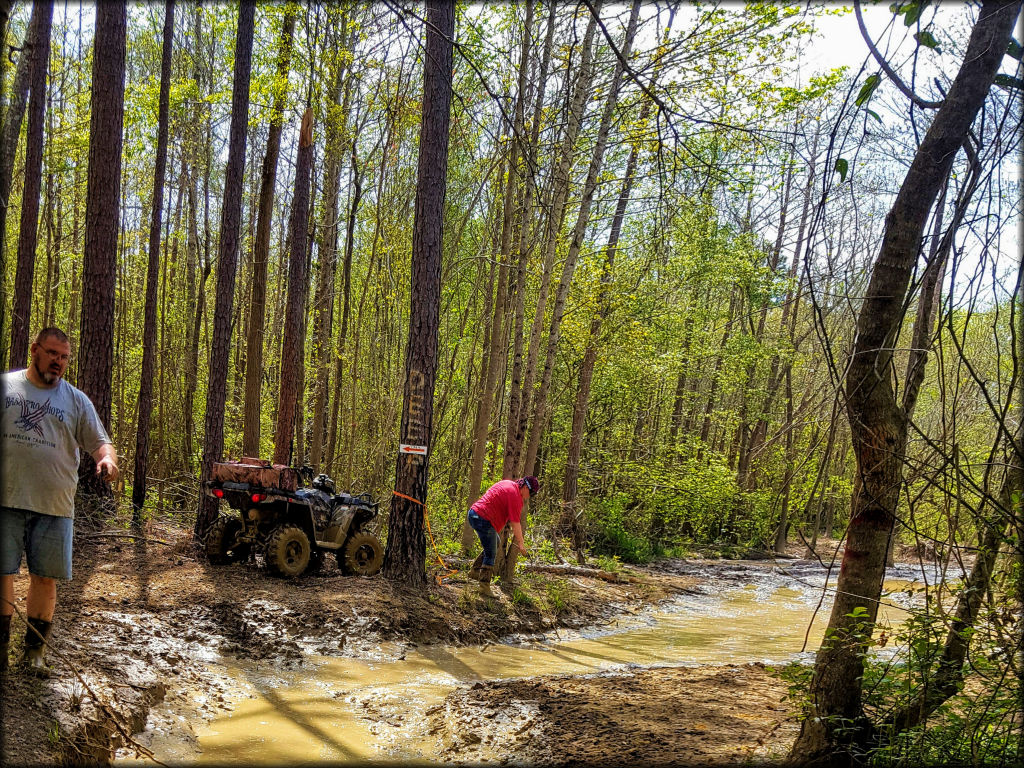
[431,664,799,766]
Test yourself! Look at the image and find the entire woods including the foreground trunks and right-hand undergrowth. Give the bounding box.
[0,0,1024,765]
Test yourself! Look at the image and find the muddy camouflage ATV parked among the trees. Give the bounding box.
[204,459,384,577]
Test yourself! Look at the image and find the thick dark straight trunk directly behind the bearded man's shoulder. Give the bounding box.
[78,0,127,497]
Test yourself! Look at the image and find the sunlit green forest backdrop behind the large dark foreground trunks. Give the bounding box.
[0,1,1020,561]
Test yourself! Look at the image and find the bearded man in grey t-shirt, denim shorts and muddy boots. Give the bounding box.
[0,328,118,675]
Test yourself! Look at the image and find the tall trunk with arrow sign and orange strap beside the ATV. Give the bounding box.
[384,0,455,587]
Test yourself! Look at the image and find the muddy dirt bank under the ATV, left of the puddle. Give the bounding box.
[0,522,693,766]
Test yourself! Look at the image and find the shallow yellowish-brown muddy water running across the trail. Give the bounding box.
[118,561,958,765]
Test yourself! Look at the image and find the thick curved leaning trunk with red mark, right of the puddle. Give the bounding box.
[791,0,1020,764]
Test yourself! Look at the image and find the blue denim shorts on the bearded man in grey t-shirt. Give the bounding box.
[0,507,75,580]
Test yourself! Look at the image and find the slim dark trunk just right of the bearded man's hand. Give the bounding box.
[131,0,175,525]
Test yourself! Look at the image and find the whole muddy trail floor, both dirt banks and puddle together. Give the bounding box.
[2,522,958,765]
